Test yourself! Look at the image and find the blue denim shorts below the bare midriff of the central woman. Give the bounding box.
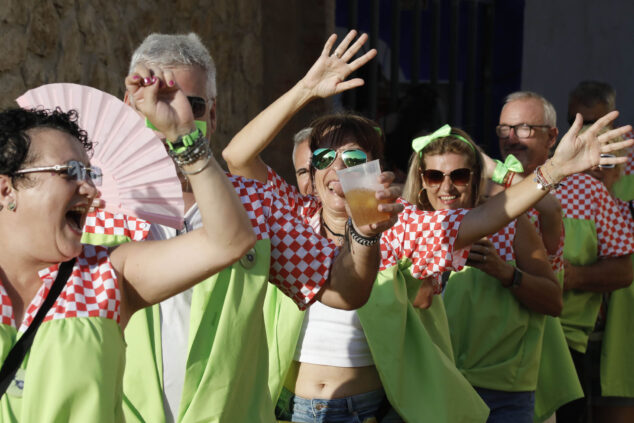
[275,388,403,423]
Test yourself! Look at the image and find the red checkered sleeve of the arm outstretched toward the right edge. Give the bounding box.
[380,199,469,279]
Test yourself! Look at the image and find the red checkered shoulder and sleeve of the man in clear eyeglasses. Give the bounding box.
[555,173,634,257]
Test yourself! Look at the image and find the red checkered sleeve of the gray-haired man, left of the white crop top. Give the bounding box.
[229,176,338,310]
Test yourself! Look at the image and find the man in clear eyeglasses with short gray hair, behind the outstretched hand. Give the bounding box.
[496,91,634,422]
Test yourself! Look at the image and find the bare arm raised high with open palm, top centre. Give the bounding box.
[222,31,376,182]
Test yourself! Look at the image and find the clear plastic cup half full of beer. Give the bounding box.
[337,160,390,226]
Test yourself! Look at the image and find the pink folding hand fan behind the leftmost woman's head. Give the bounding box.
[16,83,184,228]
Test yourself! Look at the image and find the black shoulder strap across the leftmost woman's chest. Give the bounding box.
[0,258,76,398]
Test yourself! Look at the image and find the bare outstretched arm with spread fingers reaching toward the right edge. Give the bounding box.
[455,111,634,252]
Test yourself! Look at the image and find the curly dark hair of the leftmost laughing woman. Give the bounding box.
[0,108,93,185]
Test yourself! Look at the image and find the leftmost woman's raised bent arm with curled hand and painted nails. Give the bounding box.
[111,66,255,324]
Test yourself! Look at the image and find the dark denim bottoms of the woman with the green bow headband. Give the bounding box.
[474,386,535,423]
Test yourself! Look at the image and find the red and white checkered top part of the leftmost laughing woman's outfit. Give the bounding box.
[0,245,121,332]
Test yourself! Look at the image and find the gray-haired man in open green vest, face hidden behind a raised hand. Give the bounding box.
[115,30,402,423]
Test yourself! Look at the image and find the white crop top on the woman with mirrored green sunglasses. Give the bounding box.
[294,302,374,367]
